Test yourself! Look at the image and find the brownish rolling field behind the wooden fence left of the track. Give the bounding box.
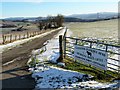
[0,21,40,44]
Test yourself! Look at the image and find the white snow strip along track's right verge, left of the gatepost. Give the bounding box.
[28,28,66,63]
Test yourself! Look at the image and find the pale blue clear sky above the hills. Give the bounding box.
[0,0,118,18]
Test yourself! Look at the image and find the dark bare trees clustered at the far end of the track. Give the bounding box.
[37,14,64,30]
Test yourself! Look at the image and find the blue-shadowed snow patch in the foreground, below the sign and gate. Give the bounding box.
[29,66,117,90]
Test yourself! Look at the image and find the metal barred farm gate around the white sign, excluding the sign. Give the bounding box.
[63,30,120,73]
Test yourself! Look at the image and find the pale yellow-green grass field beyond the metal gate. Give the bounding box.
[64,19,118,41]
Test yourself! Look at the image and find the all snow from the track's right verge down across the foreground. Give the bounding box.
[29,29,117,90]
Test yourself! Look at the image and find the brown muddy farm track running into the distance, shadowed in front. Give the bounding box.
[0,30,60,90]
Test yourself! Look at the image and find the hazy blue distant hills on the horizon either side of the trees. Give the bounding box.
[3,12,118,22]
